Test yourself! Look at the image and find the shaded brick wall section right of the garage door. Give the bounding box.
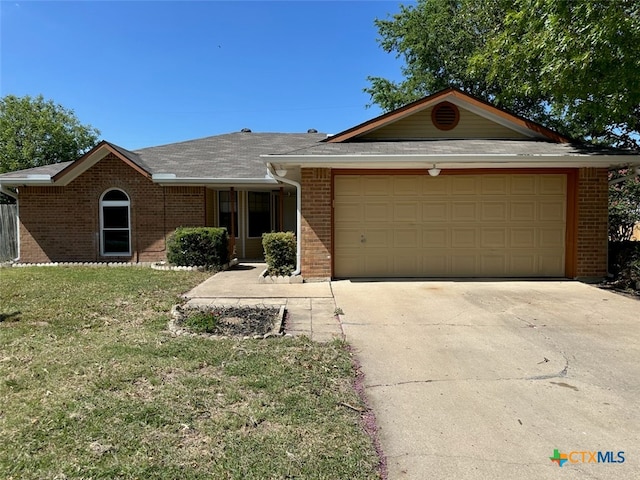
[576,168,609,278]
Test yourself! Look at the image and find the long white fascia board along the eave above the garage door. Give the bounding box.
[265,154,640,168]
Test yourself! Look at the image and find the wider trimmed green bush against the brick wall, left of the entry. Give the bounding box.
[167,227,229,268]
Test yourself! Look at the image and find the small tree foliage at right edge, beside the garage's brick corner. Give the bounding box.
[609,169,640,242]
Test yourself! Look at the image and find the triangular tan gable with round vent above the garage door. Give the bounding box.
[326,88,570,143]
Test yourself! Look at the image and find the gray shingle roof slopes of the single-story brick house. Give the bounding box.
[0,132,637,181]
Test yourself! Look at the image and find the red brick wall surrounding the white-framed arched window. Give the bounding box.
[19,154,206,263]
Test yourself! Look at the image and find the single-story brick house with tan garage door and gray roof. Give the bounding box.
[0,89,640,279]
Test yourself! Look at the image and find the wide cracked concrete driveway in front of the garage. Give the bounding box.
[332,280,640,480]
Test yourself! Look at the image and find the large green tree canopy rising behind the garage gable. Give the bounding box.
[365,0,640,149]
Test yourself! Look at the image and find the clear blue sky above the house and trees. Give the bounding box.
[0,0,412,150]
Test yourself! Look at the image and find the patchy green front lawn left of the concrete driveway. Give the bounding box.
[0,267,379,480]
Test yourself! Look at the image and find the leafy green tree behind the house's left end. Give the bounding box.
[0,95,100,173]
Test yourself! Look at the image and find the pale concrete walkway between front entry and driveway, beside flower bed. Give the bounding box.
[185,263,343,342]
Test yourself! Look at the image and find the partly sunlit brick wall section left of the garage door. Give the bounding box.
[300,168,331,280]
